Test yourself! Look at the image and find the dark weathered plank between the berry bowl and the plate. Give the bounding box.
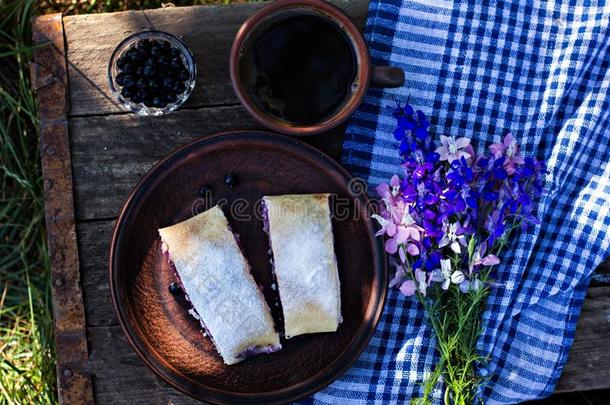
[70,102,343,220]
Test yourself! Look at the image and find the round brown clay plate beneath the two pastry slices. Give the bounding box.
[109,132,387,403]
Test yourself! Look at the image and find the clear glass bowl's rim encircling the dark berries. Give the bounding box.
[108,31,197,115]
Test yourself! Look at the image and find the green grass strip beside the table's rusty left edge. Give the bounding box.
[0,0,56,404]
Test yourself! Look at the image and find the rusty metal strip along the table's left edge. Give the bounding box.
[31,14,93,404]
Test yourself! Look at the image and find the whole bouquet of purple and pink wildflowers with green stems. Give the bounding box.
[373,104,545,404]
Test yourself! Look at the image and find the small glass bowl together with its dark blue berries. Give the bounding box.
[108,31,197,115]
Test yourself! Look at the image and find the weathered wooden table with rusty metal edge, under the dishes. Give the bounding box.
[32,1,610,404]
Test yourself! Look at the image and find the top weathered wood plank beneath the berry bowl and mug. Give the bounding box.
[64,0,368,116]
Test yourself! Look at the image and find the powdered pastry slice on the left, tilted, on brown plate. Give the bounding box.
[159,206,281,364]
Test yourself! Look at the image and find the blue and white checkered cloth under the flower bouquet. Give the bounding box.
[310,0,610,404]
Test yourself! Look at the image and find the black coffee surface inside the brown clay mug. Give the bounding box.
[240,14,356,124]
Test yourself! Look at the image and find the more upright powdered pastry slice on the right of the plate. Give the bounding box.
[263,194,342,338]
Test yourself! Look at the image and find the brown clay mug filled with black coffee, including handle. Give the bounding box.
[230,0,404,135]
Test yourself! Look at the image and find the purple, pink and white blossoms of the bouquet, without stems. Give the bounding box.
[372,104,546,296]
